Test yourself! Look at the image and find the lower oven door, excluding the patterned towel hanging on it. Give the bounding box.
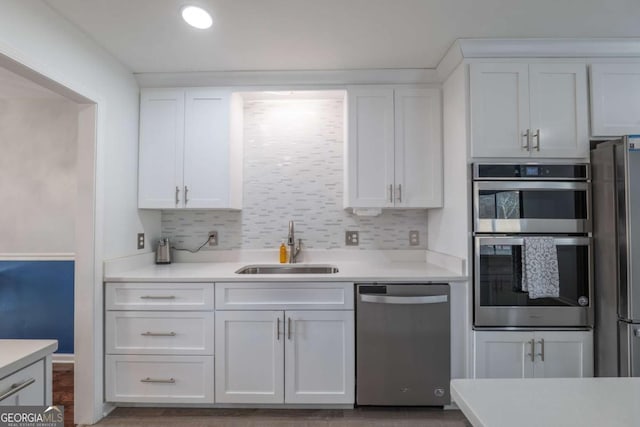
[474,236,593,327]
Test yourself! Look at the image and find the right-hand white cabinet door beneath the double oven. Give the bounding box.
[534,331,593,378]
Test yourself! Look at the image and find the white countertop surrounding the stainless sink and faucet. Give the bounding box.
[104,261,467,282]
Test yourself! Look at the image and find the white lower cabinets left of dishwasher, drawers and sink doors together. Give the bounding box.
[105,282,355,406]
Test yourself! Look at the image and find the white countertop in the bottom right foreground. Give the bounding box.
[451,378,640,427]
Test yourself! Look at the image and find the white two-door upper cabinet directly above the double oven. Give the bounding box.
[470,62,589,158]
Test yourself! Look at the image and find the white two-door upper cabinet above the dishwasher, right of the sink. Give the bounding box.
[344,87,442,208]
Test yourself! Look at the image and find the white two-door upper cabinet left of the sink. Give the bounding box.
[138,89,242,209]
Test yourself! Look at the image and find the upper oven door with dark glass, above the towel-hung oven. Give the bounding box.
[473,181,591,234]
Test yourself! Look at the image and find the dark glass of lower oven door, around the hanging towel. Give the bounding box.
[476,237,590,307]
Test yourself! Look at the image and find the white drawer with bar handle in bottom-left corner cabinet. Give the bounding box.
[0,360,46,406]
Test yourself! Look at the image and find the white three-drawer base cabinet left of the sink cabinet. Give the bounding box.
[105,283,214,404]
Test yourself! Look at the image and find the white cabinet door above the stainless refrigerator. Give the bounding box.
[591,64,640,136]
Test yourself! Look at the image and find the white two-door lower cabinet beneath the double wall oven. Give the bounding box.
[474,331,593,378]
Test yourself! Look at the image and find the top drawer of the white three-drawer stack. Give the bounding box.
[105,283,213,310]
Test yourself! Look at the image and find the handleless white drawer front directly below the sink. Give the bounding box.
[216,282,353,310]
